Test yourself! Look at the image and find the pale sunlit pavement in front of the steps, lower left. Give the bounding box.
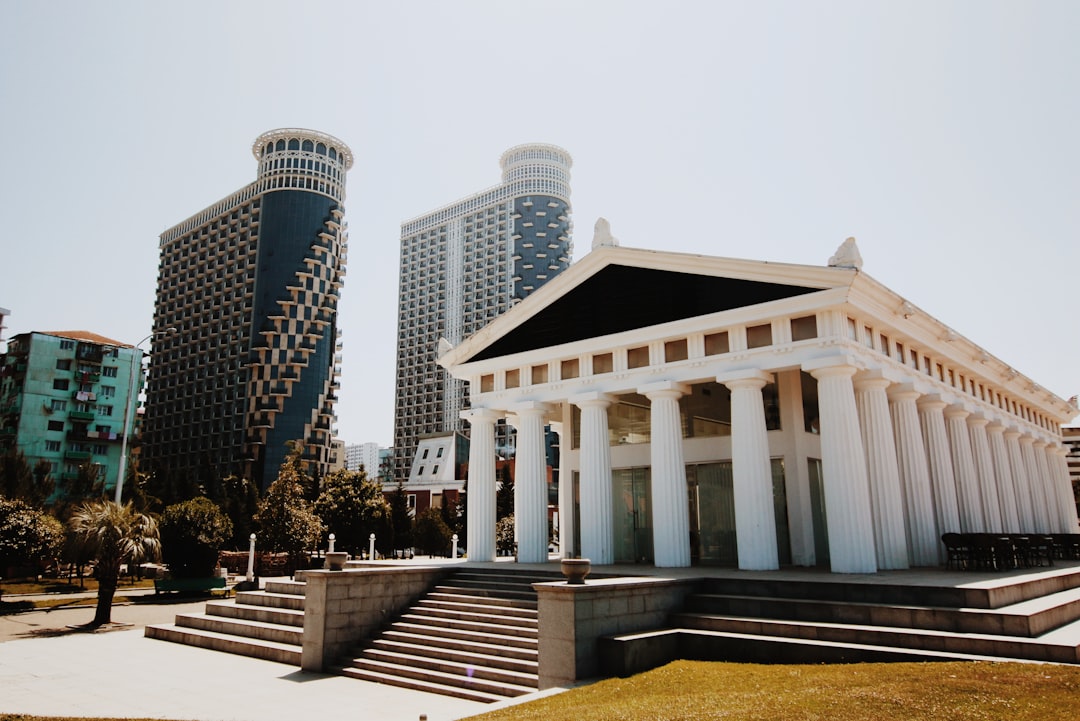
[0,601,552,721]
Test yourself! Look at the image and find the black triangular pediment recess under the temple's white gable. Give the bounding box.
[469,266,820,362]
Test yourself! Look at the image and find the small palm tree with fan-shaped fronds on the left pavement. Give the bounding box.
[68,500,161,627]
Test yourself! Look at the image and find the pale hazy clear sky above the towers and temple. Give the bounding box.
[0,0,1080,446]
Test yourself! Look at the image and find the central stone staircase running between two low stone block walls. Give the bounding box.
[341,569,563,703]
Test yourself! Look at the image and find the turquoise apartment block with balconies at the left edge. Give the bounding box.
[0,330,143,495]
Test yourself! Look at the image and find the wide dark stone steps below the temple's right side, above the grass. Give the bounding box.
[670,572,1080,664]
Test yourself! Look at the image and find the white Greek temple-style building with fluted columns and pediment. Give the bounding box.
[440,230,1078,573]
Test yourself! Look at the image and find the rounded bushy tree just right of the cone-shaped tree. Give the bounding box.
[315,470,393,554]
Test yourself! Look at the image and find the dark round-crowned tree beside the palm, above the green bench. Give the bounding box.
[160,498,232,579]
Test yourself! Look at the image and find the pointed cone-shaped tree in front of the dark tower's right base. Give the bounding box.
[255,444,323,569]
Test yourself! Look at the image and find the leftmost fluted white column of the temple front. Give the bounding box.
[461,408,502,561]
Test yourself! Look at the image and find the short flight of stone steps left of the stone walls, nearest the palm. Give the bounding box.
[146,581,305,666]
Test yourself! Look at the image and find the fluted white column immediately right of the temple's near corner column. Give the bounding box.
[854,372,909,570]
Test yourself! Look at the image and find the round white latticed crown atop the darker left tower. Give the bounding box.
[252,127,352,201]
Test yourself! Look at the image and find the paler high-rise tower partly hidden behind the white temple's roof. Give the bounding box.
[394,144,573,478]
